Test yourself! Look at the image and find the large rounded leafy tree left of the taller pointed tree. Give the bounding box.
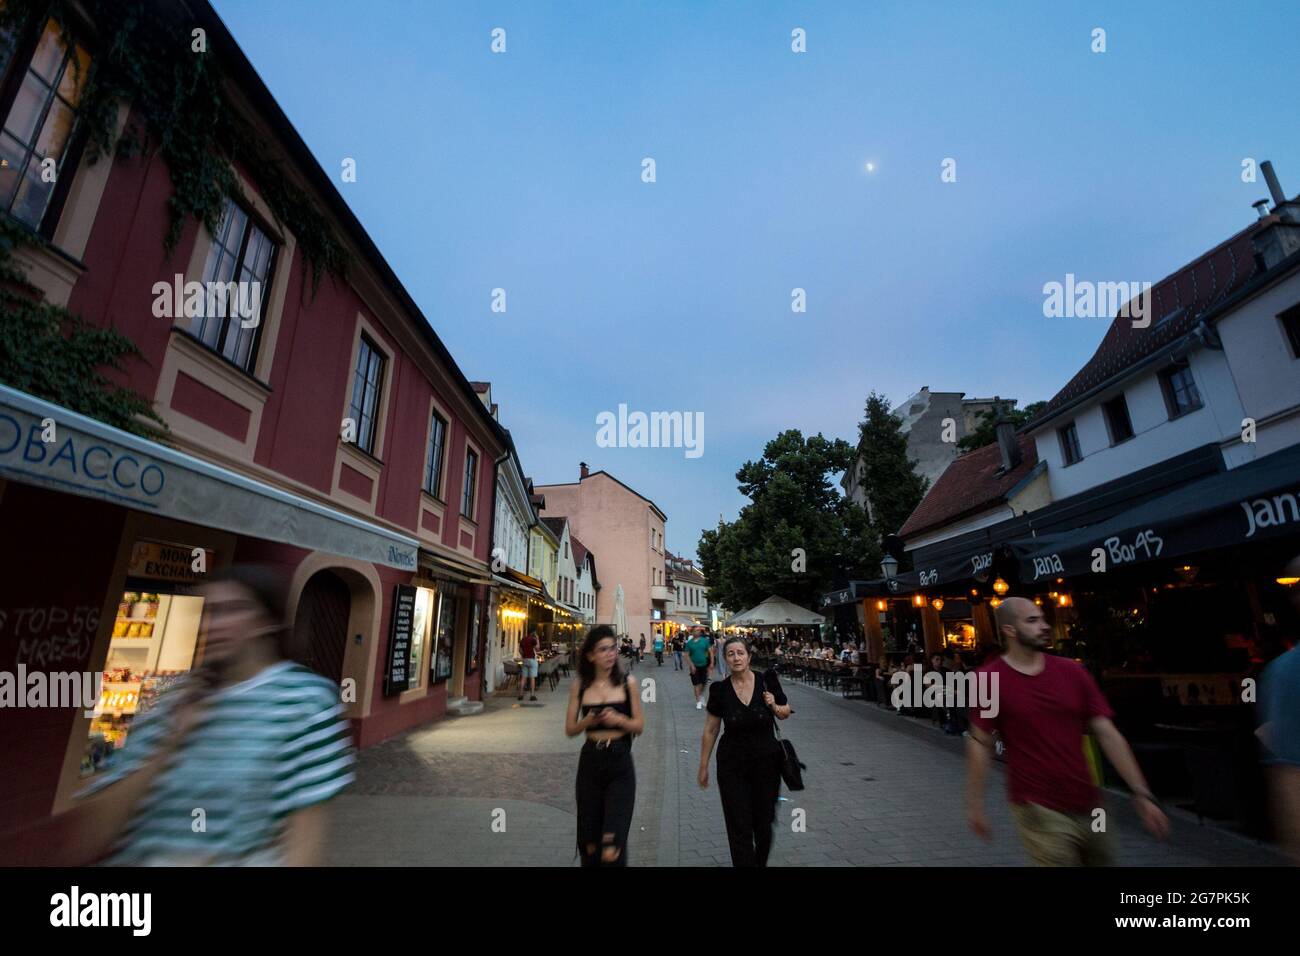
[698,429,879,610]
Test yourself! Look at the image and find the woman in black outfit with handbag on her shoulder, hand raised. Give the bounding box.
[699,637,793,866]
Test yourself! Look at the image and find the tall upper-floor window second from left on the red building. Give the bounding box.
[190,198,276,372]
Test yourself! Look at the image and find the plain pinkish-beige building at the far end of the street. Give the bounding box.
[534,462,672,643]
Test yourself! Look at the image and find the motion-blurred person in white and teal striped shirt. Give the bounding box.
[69,566,355,866]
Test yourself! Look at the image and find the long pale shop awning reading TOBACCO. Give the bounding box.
[0,385,419,571]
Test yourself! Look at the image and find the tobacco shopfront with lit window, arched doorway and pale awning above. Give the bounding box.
[0,386,417,858]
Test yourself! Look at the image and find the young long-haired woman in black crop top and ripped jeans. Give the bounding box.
[564,624,645,866]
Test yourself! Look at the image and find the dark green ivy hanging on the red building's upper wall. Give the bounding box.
[0,0,348,437]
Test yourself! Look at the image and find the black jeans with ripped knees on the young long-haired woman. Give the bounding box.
[575,737,637,866]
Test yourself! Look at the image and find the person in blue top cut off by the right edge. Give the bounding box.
[1258,555,1300,864]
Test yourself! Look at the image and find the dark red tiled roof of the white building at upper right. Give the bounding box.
[1027,221,1266,428]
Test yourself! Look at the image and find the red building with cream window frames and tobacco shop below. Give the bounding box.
[0,4,507,848]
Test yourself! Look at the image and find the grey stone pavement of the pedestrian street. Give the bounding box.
[325,657,1278,866]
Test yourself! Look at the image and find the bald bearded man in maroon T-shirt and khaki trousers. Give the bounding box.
[966,597,1169,866]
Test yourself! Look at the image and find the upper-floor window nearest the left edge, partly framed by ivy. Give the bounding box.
[0,20,91,238]
